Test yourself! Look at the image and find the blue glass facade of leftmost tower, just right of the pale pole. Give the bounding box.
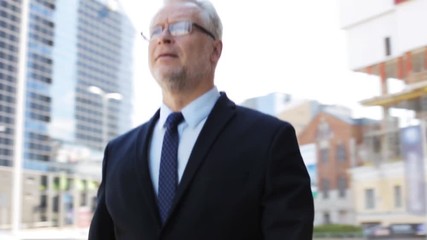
[23,0,56,169]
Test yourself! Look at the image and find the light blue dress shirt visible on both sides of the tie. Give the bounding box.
[148,87,220,194]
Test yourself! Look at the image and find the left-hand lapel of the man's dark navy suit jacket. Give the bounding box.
[134,111,160,225]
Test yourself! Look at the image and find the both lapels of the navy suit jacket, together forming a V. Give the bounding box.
[135,92,236,229]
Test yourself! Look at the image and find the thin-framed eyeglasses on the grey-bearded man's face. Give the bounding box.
[141,21,215,40]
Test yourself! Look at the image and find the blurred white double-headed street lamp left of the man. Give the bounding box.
[88,86,122,145]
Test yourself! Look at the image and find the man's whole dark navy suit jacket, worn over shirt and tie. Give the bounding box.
[89,93,314,240]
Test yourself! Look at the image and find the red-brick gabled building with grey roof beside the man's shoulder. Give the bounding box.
[243,93,377,225]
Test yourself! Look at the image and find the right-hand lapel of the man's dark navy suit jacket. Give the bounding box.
[165,93,236,224]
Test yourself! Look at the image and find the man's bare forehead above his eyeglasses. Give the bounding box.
[151,2,200,26]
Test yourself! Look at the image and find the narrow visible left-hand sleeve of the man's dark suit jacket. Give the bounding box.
[88,143,116,240]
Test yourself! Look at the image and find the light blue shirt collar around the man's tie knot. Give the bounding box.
[159,87,220,128]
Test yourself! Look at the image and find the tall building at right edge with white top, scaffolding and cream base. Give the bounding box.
[340,0,427,230]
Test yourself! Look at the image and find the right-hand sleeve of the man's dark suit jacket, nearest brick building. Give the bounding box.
[262,124,314,240]
